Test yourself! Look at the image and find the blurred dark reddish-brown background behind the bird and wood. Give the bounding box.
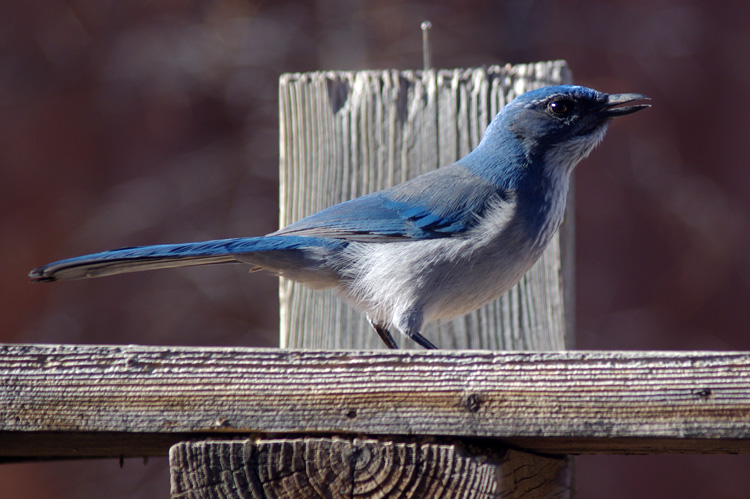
[0,0,750,498]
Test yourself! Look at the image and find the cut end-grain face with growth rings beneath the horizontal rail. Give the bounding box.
[169,438,506,499]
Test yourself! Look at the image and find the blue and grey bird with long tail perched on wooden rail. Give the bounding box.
[29,85,649,348]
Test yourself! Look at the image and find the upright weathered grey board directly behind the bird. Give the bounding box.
[279,61,574,350]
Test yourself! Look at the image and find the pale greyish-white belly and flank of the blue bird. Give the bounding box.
[337,195,552,323]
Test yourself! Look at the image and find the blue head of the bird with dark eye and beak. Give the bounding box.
[483,85,650,184]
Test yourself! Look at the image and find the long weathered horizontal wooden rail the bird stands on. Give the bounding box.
[0,345,750,458]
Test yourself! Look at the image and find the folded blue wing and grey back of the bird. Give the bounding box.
[274,165,503,241]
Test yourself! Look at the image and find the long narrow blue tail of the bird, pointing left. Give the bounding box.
[29,236,344,282]
